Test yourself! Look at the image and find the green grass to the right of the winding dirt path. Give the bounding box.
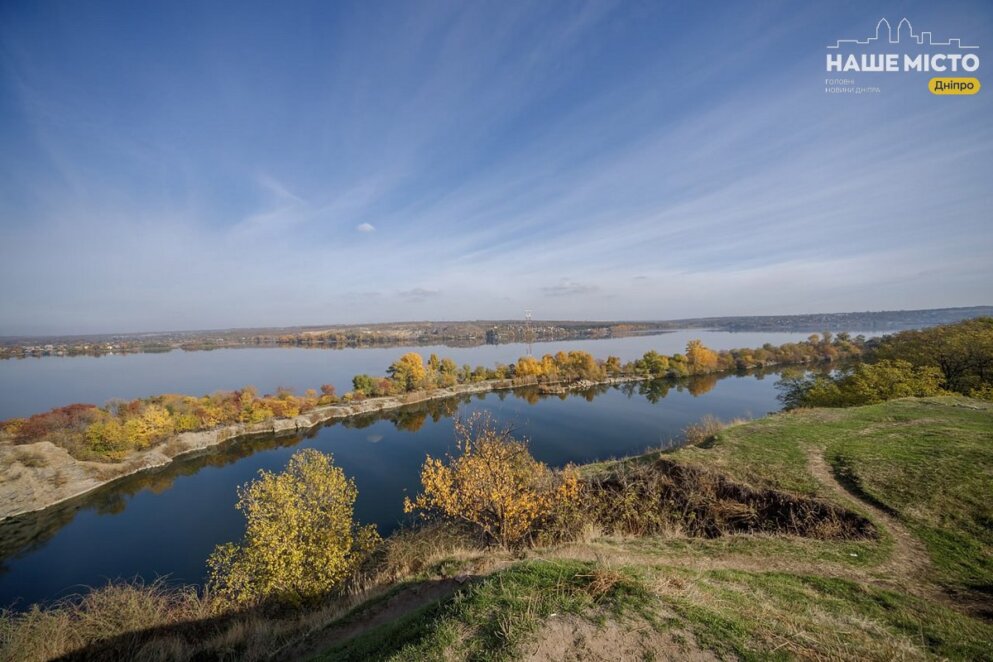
[826,398,993,594]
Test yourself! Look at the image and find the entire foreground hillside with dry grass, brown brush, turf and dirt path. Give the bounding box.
[0,396,993,660]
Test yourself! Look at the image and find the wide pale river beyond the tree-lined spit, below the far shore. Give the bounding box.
[0,329,870,420]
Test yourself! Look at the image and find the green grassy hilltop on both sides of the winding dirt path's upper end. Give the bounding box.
[671,396,993,594]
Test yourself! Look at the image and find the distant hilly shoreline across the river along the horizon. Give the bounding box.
[0,306,993,359]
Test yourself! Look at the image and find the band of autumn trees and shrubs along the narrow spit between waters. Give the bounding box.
[0,333,863,462]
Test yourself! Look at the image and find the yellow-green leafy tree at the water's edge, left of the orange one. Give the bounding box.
[207,449,379,604]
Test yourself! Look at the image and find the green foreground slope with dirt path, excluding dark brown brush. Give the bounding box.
[310,397,993,660]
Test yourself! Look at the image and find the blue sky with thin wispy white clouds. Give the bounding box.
[0,0,993,335]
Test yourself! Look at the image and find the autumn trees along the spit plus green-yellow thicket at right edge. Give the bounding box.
[0,318,993,462]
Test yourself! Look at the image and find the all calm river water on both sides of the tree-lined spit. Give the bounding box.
[0,332,868,607]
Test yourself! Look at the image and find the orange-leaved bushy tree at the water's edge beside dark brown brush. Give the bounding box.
[404,415,579,547]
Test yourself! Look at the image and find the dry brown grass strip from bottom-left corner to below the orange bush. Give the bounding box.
[0,522,492,662]
